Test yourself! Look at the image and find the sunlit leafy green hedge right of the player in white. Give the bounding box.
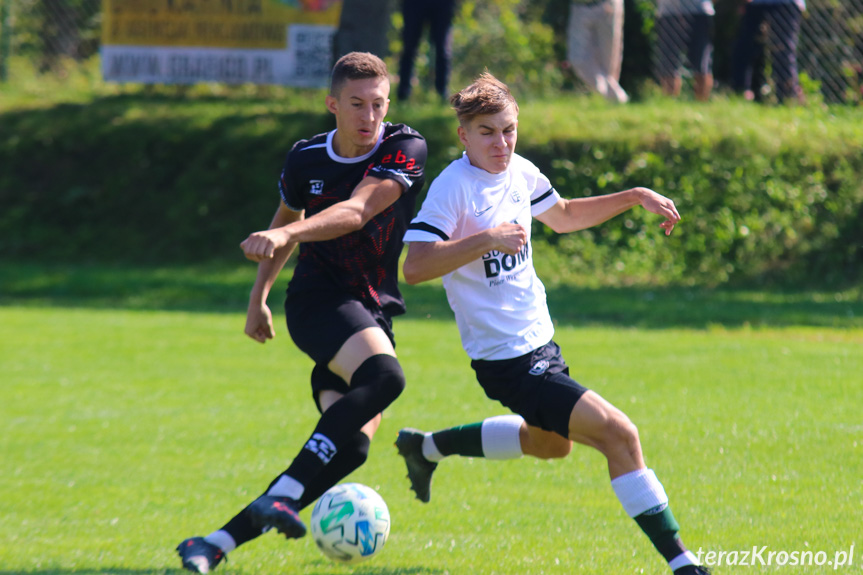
[540,139,863,285]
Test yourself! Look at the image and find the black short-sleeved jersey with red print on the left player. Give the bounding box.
[279,123,426,316]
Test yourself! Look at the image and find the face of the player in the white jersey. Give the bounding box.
[458,106,518,174]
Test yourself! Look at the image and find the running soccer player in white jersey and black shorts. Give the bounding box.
[396,73,707,575]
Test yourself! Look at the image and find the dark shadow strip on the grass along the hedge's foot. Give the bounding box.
[0,262,863,328]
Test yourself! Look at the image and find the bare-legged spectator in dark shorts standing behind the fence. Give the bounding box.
[656,0,716,101]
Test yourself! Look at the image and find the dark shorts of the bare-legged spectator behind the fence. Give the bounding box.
[656,14,713,78]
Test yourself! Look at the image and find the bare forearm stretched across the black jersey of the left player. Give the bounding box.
[240,176,404,262]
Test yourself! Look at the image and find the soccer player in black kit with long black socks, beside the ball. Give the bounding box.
[177,52,426,573]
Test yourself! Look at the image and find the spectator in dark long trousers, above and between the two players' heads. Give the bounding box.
[397,0,455,100]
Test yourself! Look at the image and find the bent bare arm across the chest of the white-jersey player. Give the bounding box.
[402,222,527,285]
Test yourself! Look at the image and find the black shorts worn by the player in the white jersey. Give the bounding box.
[470,341,587,438]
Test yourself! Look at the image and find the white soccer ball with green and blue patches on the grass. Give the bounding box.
[312,483,390,564]
